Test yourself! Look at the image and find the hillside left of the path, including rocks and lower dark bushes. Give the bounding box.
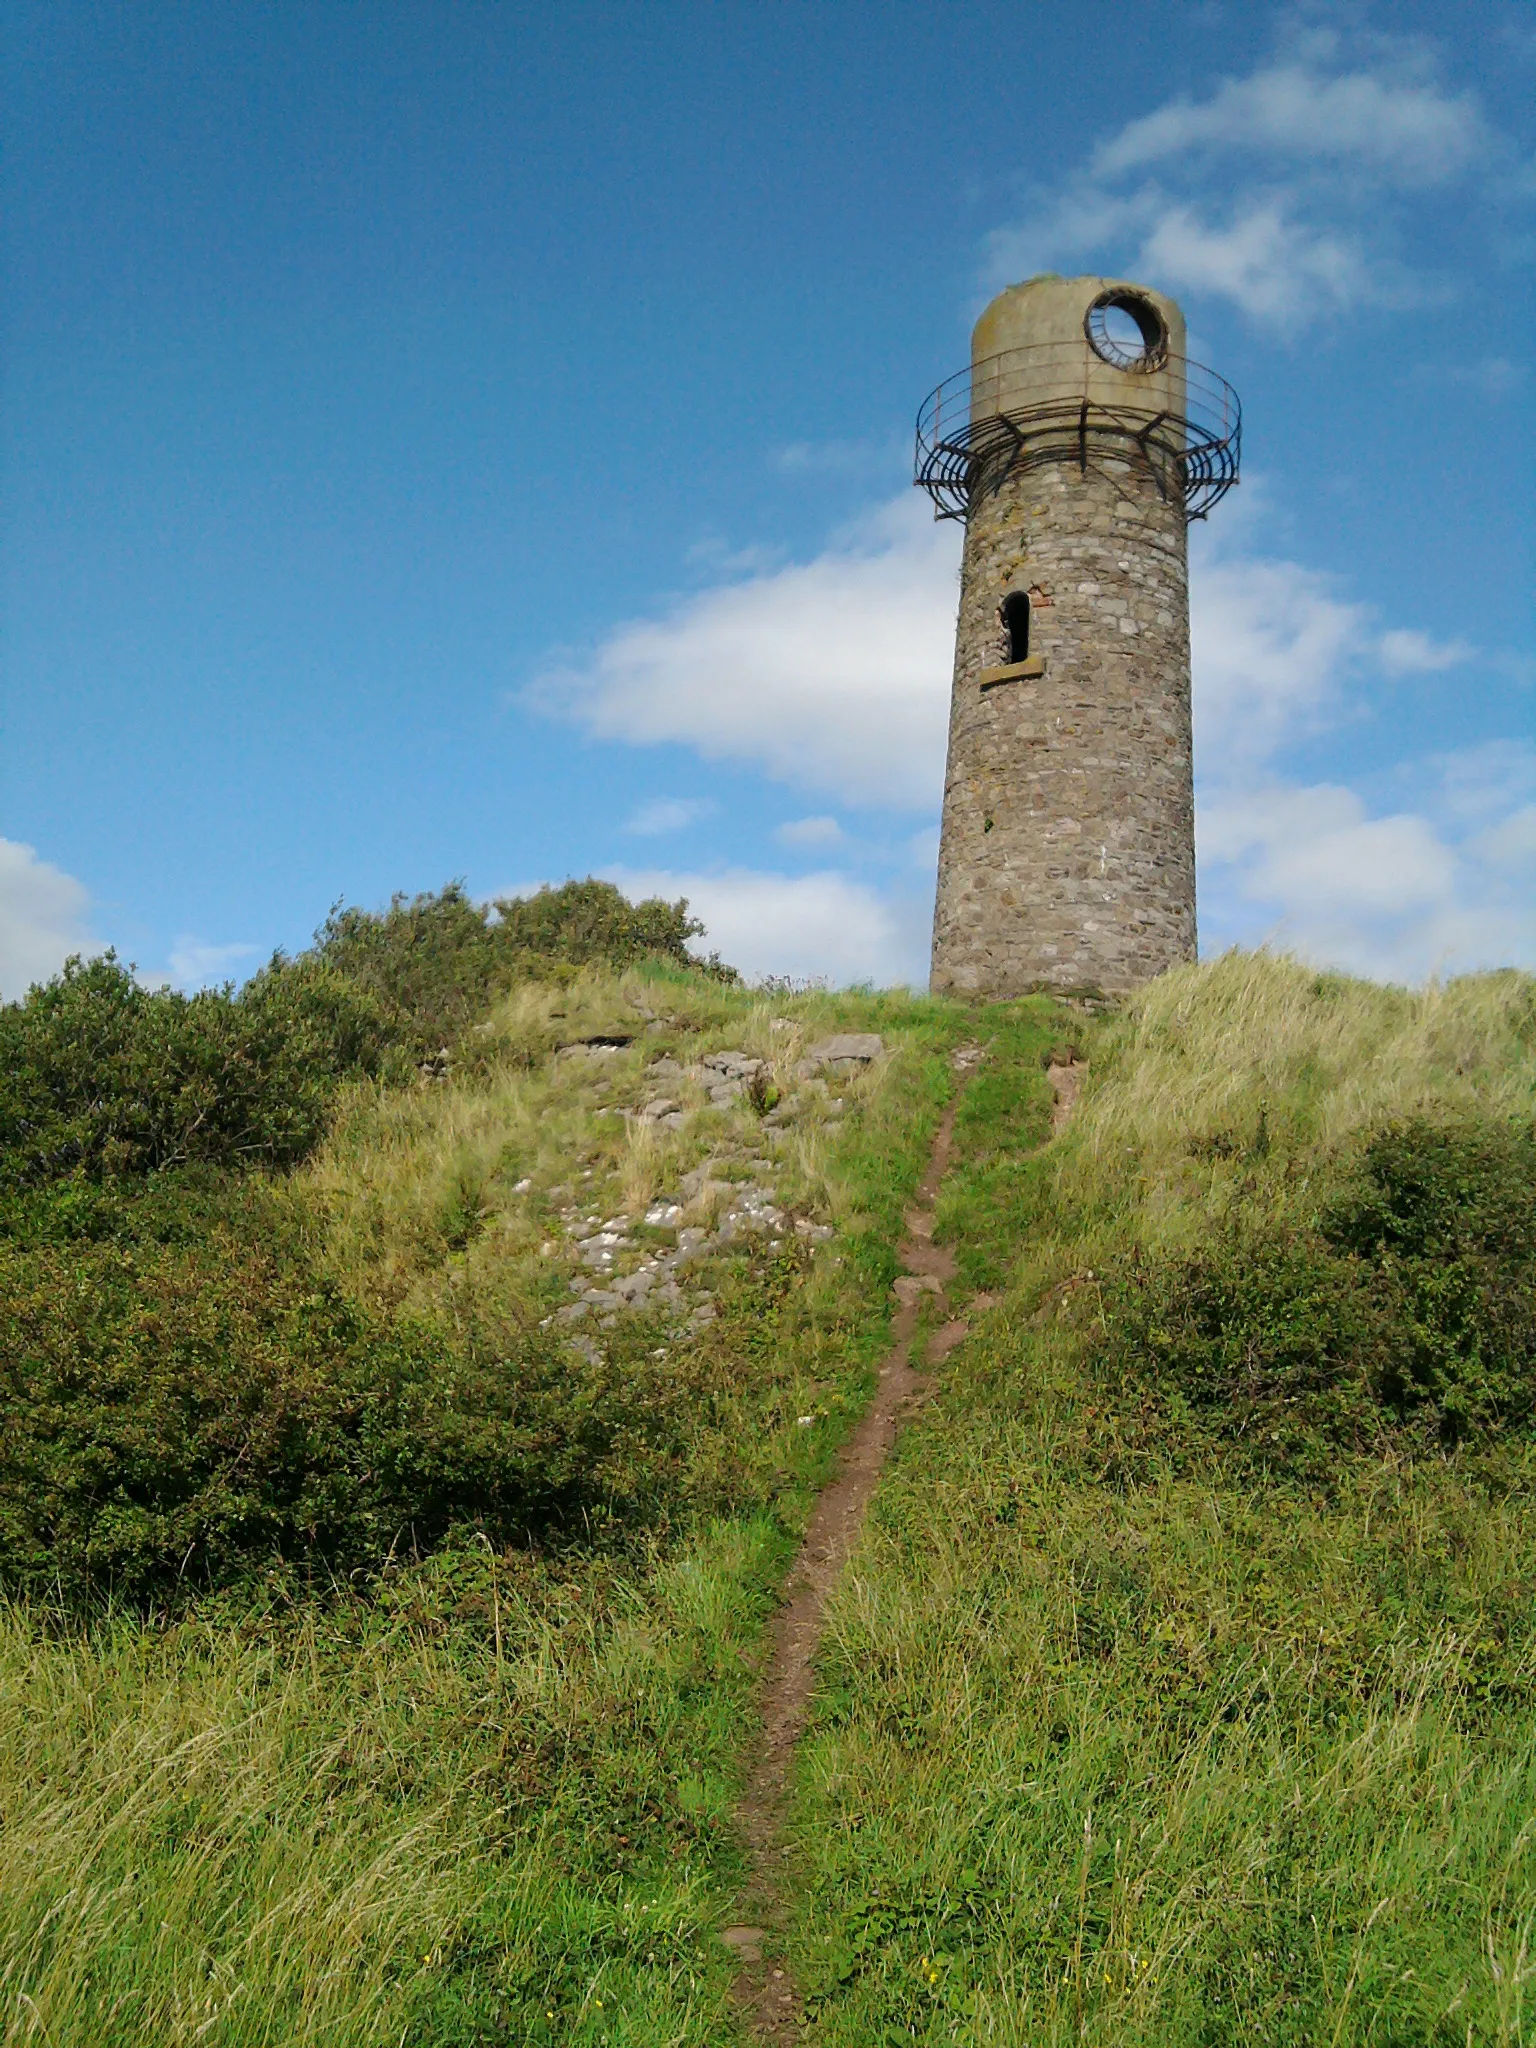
[0,963,1073,2048]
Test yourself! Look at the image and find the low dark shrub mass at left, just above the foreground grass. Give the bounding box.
[0,1190,696,1602]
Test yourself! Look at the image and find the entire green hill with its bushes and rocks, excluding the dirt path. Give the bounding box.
[0,917,1536,2048]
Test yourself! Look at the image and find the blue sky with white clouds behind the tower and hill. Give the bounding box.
[0,0,1536,995]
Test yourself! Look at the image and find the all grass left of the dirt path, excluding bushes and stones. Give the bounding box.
[0,971,1011,2048]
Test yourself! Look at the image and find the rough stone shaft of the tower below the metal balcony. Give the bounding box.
[932,457,1194,997]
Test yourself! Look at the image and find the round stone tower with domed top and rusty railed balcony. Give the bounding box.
[918,276,1241,997]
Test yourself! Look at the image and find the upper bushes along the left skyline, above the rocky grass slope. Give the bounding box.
[0,881,731,1192]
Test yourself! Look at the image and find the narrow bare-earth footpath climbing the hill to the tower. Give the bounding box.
[721,1047,1081,2042]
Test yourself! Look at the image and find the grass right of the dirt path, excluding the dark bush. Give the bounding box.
[793,956,1536,2048]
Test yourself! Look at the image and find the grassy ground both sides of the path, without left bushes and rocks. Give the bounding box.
[12,956,1536,2048]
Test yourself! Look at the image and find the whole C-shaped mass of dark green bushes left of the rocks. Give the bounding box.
[0,881,729,1599]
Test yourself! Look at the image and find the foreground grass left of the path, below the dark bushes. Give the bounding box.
[0,1518,786,2048]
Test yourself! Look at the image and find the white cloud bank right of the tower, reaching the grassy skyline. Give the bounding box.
[1190,526,1536,981]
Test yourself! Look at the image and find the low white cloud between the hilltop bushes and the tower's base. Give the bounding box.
[608,868,928,987]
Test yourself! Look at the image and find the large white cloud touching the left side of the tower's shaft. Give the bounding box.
[528,492,961,809]
